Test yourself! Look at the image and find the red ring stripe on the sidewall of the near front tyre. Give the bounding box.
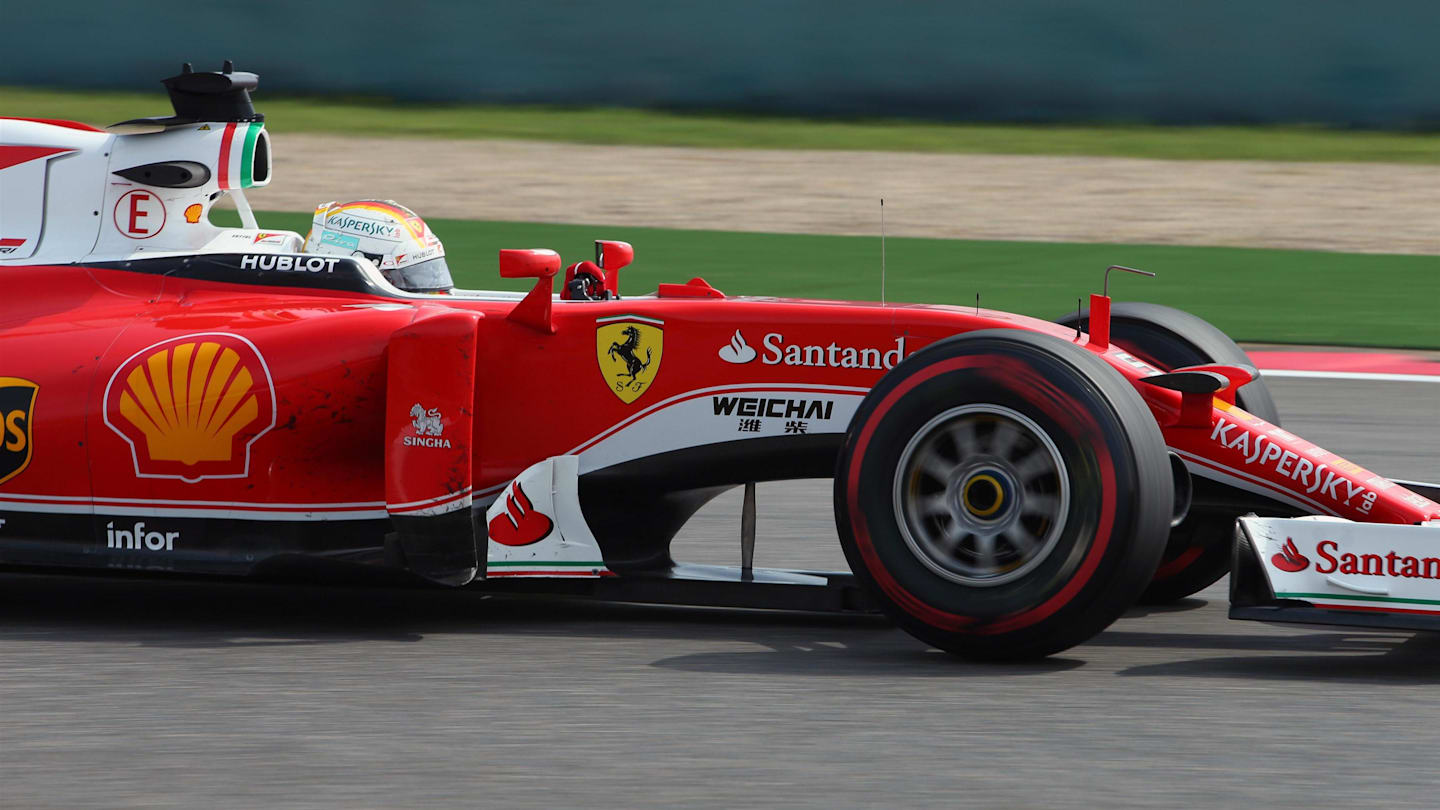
[845,356,1116,634]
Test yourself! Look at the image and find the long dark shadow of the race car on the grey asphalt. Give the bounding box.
[8,574,1440,683]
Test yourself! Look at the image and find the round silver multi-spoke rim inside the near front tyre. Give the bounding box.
[894,404,1070,587]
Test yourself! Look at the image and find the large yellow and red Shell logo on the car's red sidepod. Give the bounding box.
[104,333,275,483]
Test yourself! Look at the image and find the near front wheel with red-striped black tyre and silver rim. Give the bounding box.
[835,330,1172,659]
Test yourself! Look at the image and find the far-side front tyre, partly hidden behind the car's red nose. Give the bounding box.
[1057,301,1280,604]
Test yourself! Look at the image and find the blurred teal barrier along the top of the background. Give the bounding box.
[11,0,1440,128]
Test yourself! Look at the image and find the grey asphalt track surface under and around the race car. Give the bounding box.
[0,379,1440,809]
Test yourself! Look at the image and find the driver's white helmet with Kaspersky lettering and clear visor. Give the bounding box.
[302,200,455,293]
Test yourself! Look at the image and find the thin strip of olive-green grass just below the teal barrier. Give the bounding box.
[11,88,1440,163]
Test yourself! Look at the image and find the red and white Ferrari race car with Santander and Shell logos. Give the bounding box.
[0,65,1440,657]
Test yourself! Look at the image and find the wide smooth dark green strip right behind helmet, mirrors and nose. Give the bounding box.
[215,212,1440,349]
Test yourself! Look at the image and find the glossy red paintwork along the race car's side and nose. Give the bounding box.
[0,259,1440,523]
